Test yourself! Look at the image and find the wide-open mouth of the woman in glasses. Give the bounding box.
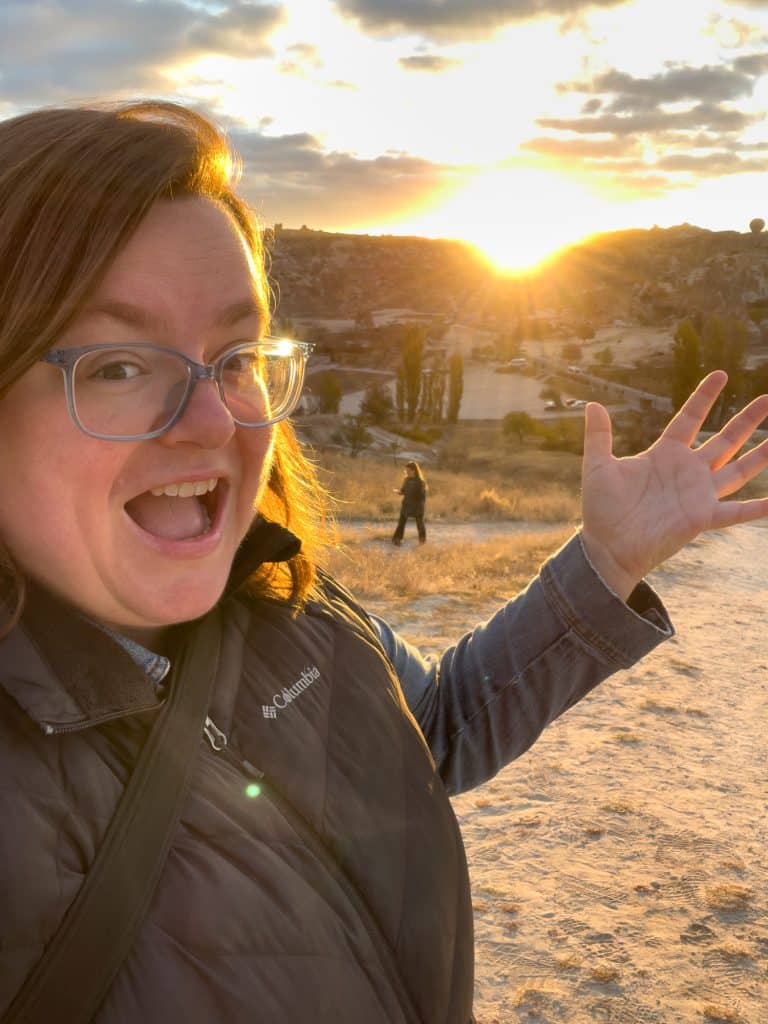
[125,478,227,541]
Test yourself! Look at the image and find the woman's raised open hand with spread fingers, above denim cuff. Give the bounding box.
[582,370,768,599]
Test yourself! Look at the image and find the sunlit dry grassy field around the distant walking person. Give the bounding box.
[307,426,581,622]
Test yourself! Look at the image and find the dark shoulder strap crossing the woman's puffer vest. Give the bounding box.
[2,608,221,1024]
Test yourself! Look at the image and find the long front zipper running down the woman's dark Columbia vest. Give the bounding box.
[203,717,423,1024]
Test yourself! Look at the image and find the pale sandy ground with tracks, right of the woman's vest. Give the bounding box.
[360,526,768,1024]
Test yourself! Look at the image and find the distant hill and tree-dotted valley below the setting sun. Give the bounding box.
[269,221,768,462]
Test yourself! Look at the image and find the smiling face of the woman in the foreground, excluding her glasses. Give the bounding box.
[0,198,272,643]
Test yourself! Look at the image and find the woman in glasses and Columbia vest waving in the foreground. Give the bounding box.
[0,102,768,1024]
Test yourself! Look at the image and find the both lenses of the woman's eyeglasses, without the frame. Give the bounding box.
[73,344,302,437]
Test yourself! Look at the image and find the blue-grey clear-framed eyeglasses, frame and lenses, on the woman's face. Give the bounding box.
[40,338,314,441]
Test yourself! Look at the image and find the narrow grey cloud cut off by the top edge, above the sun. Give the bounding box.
[335,0,628,39]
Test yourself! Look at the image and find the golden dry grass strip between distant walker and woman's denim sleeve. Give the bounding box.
[325,529,571,602]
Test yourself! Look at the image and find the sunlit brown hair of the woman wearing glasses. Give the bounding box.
[0,100,330,636]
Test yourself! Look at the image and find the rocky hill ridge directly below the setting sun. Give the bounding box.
[267,224,768,327]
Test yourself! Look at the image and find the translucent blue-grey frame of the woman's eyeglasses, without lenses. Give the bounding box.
[39,335,314,441]
